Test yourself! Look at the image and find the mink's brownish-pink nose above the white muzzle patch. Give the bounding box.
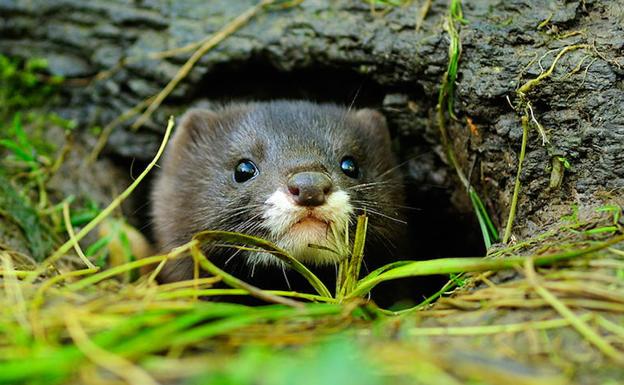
[286,171,332,206]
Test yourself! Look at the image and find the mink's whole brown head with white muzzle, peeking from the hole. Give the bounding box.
[152,101,403,281]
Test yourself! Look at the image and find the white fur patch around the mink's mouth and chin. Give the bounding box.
[249,190,353,265]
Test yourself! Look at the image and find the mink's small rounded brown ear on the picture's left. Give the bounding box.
[171,109,219,147]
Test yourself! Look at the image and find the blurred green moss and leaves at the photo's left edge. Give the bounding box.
[0,55,75,260]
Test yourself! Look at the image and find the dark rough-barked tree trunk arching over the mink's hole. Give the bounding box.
[0,0,624,234]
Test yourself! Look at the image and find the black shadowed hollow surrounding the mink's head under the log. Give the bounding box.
[124,61,485,307]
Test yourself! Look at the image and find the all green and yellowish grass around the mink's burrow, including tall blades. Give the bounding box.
[0,0,624,385]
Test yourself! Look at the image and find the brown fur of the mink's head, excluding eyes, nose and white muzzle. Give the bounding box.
[152,101,403,281]
